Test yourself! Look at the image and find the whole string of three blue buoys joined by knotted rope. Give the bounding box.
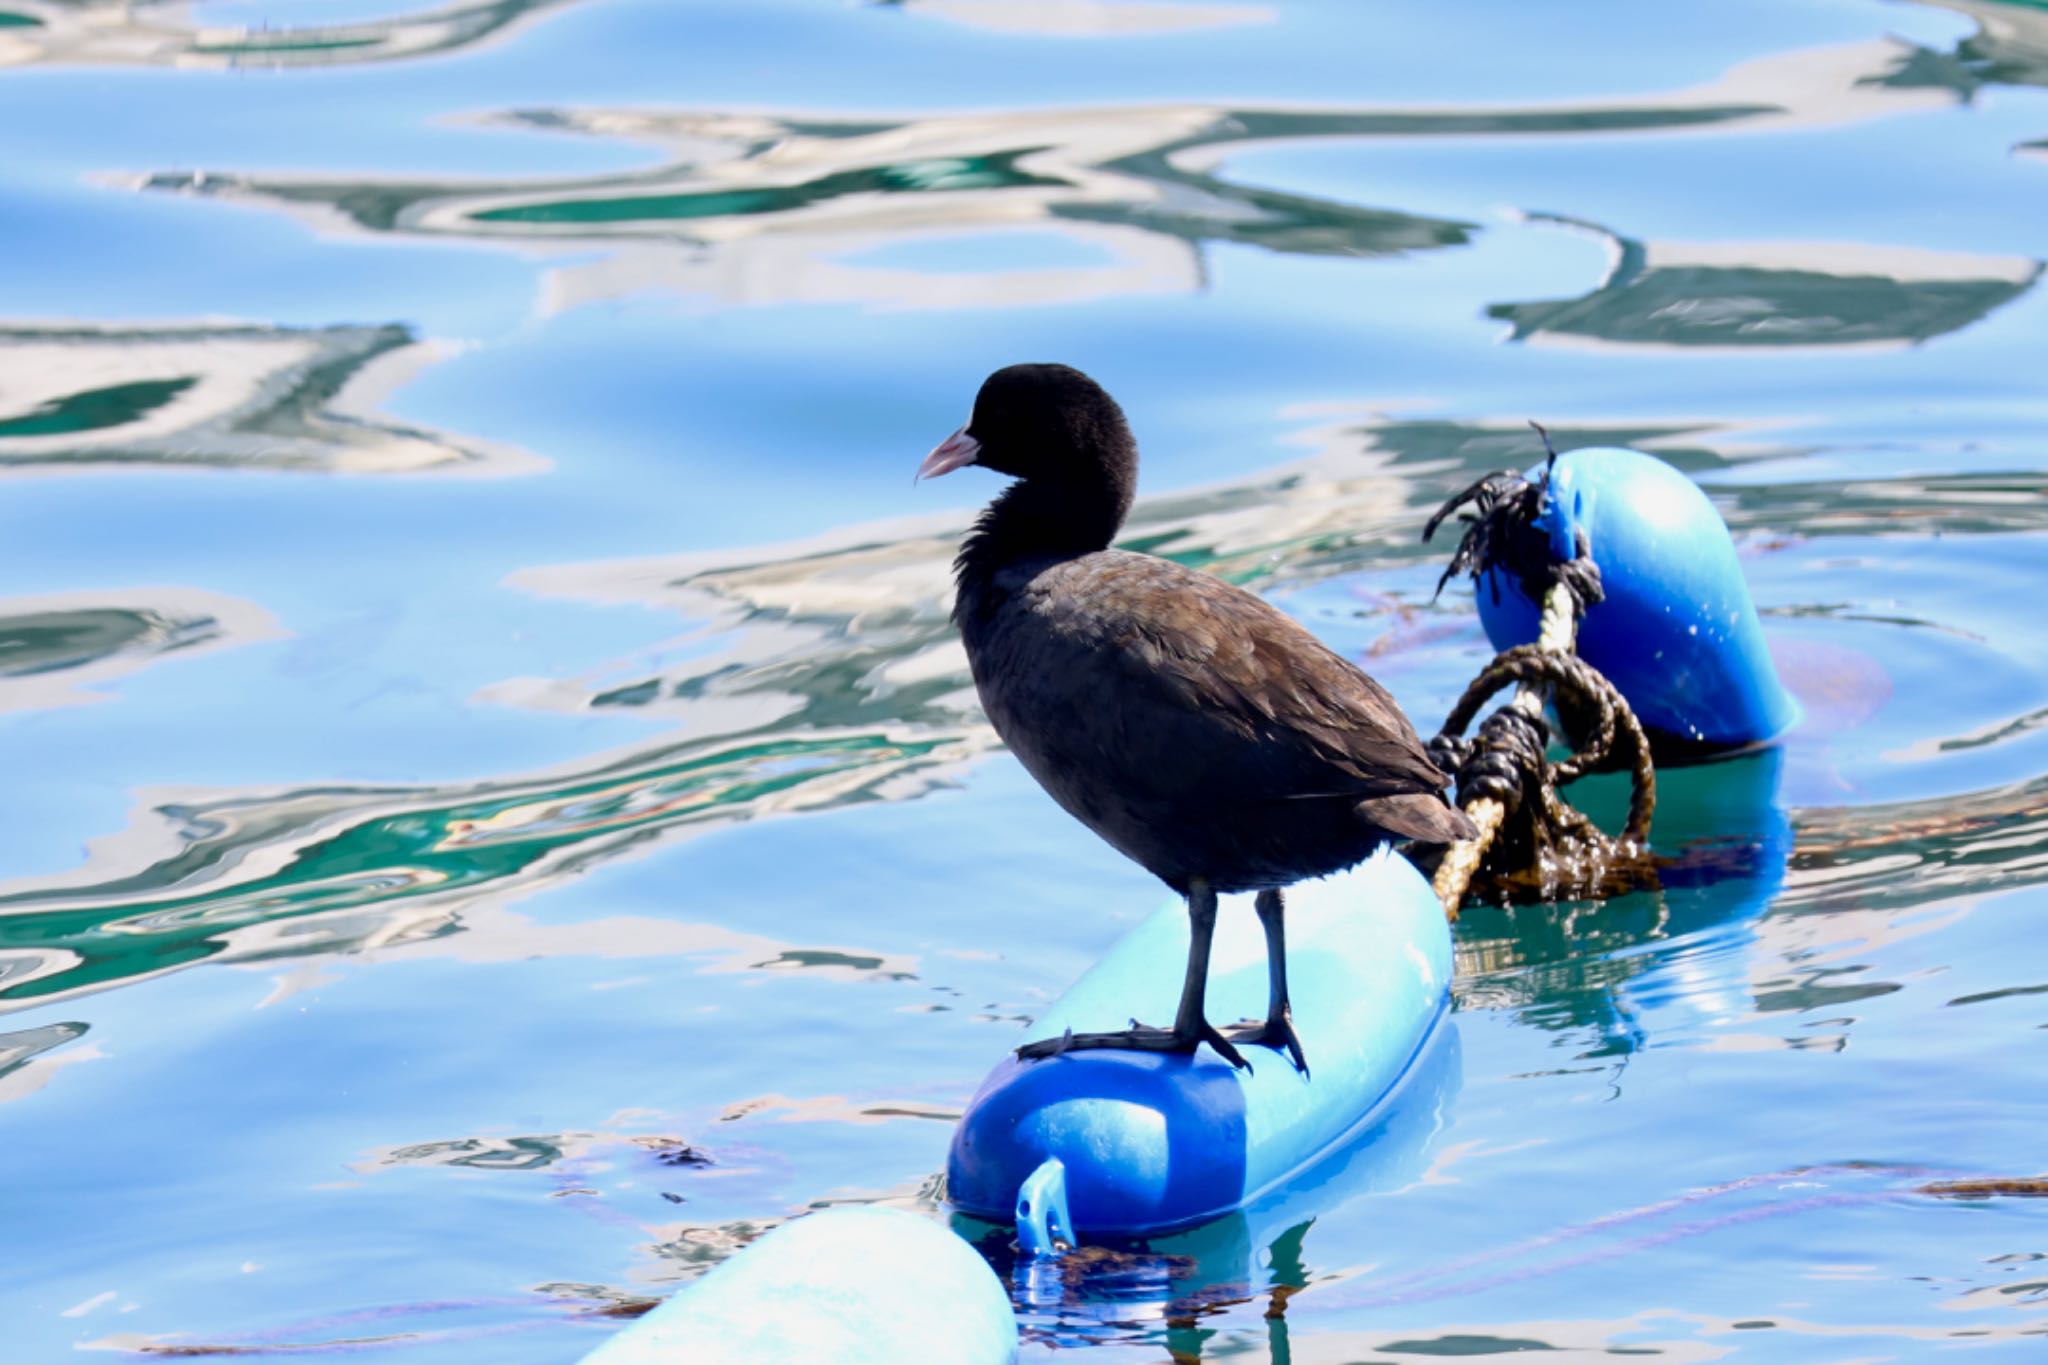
[590,424,1826,1365]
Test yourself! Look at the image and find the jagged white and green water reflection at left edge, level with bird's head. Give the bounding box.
[0,323,547,475]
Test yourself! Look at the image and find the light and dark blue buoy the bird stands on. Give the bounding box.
[946,849,1450,1250]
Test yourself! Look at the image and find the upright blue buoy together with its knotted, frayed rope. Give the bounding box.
[1421,422,1798,919]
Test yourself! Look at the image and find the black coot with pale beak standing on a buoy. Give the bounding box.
[920,364,1475,1070]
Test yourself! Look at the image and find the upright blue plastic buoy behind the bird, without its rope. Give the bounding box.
[1479,446,1798,751]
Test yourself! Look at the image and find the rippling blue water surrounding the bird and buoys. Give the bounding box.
[0,0,2048,1365]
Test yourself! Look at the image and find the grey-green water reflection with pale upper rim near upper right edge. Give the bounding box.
[1487,217,2042,346]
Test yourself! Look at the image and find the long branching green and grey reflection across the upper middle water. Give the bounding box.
[145,104,1778,272]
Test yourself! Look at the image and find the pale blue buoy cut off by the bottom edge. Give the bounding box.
[584,1207,1018,1365]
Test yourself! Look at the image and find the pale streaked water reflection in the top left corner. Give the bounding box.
[0,0,569,70]
